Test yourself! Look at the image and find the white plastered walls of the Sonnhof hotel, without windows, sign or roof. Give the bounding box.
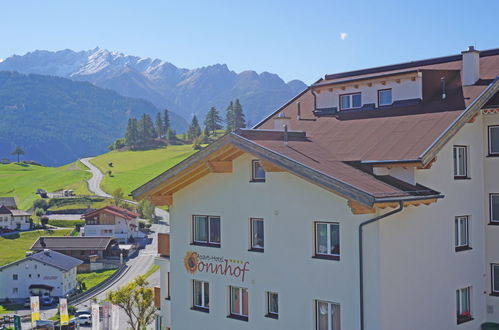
[152,110,499,330]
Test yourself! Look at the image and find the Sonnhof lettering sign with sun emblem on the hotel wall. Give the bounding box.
[184,251,249,282]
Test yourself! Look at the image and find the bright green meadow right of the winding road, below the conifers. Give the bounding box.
[91,145,195,196]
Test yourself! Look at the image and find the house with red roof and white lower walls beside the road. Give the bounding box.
[81,205,144,242]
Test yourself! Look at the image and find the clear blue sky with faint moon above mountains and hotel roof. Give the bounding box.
[0,0,499,84]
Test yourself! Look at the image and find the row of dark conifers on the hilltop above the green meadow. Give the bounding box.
[109,99,246,150]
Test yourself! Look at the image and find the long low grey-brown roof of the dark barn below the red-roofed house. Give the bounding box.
[31,236,112,251]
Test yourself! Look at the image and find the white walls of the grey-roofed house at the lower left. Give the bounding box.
[0,258,77,300]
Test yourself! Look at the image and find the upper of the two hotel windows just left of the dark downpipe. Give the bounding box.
[315,222,340,260]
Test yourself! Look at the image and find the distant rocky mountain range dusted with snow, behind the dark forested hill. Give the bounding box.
[0,48,306,125]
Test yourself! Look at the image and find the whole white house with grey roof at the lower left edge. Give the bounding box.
[0,250,83,301]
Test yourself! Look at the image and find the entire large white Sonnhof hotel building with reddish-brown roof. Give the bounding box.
[133,48,499,330]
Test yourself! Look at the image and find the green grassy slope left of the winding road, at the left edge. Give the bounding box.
[0,162,91,209]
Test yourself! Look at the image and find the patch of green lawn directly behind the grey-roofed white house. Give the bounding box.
[0,228,73,266]
